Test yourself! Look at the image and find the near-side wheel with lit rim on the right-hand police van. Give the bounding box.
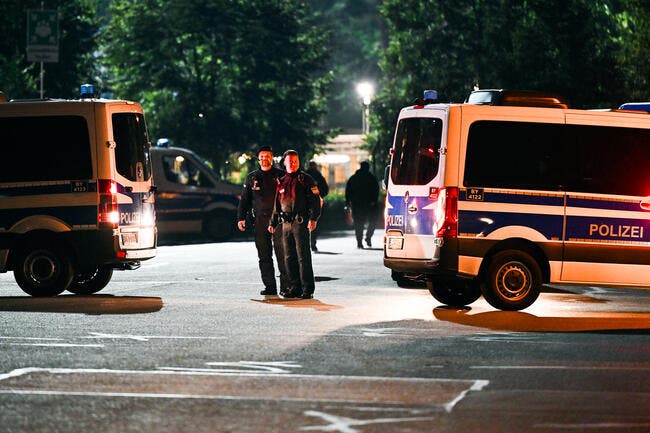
[481,250,542,311]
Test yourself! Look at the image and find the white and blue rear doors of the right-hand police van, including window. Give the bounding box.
[385,108,448,260]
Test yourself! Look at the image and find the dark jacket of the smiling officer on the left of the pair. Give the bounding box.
[237,167,285,221]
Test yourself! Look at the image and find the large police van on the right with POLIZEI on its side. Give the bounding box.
[384,90,650,310]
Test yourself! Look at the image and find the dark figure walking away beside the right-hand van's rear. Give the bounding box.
[345,161,379,248]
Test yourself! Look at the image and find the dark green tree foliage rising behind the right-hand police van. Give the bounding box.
[370,0,648,168]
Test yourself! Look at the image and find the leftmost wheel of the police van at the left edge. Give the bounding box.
[14,244,74,297]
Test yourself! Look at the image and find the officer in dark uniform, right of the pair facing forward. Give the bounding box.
[268,150,320,299]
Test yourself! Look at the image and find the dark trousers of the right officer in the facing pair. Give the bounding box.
[281,219,316,294]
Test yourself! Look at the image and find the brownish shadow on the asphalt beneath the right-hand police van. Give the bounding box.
[433,307,650,333]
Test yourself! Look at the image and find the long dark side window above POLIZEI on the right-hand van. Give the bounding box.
[464,121,650,196]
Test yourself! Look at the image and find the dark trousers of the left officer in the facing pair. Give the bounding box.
[255,218,289,290]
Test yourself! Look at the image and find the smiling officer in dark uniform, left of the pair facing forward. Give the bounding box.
[237,146,288,295]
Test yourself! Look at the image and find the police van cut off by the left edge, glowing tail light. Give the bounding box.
[0,85,156,296]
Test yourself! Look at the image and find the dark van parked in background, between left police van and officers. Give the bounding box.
[151,144,241,241]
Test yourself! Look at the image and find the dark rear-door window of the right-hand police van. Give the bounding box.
[391,118,442,185]
